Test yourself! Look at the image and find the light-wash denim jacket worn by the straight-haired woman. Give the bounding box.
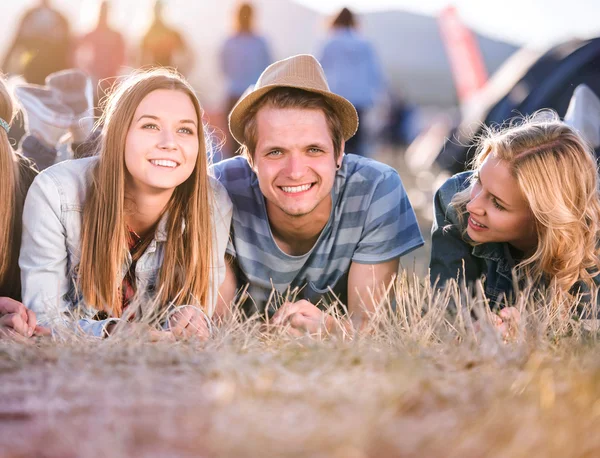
[19,157,232,337]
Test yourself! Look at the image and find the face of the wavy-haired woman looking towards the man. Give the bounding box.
[467,154,537,252]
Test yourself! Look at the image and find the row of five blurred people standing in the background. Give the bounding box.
[1,0,402,158]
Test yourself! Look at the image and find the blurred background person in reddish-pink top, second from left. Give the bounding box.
[75,0,125,105]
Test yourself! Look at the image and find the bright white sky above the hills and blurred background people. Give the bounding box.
[0,0,600,47]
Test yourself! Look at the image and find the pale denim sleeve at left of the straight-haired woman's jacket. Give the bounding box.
[19,173,115,337]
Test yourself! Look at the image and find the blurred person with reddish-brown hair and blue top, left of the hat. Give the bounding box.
[220,3,271,157]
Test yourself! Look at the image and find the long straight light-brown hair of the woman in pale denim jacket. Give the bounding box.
[78,68,213,316]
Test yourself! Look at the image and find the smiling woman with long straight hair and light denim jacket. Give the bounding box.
[19,69,231,337]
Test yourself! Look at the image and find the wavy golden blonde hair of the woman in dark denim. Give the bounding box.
[452,110,600,293]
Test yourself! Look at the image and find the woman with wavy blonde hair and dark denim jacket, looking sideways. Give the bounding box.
[430,111,600,322]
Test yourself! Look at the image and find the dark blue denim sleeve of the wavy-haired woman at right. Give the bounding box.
[429,172,482,286]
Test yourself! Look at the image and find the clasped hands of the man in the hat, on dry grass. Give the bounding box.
[271,299,334,336]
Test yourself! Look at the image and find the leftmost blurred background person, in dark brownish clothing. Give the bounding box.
[2,0,72,84]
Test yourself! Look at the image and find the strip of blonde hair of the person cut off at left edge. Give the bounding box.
[0,76,19,283]
